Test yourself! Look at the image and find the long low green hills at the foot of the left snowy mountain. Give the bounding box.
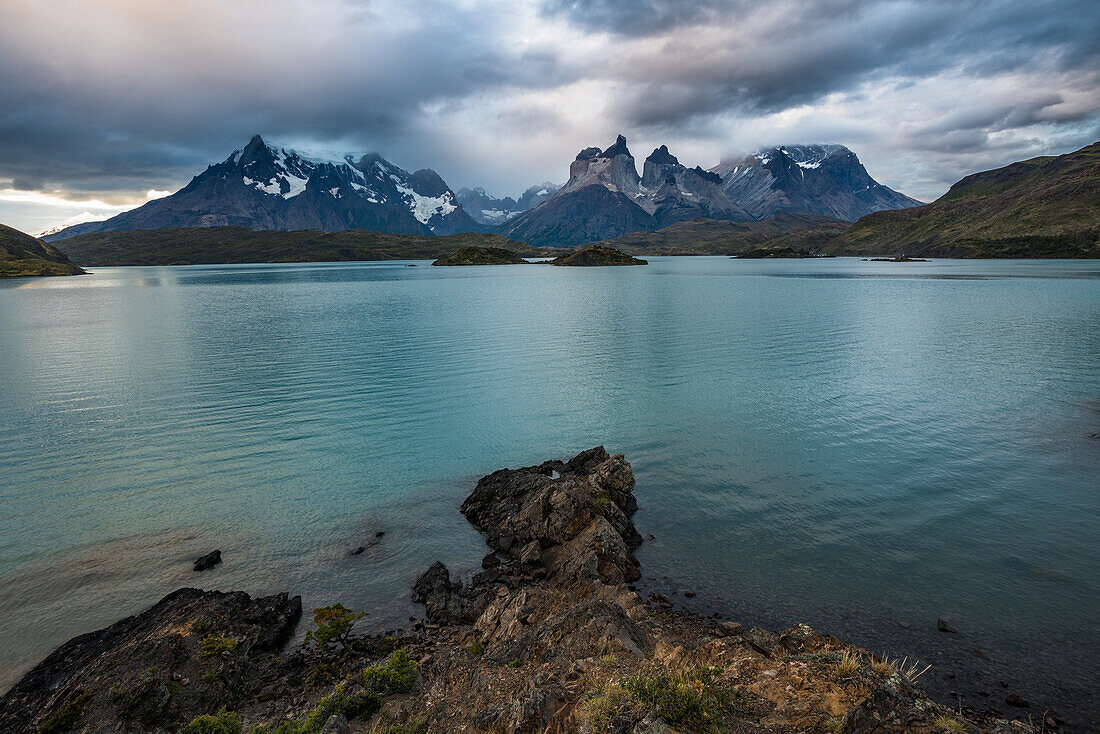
[50,227,557,266]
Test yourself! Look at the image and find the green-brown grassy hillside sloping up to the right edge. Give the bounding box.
[826,142,1100,258]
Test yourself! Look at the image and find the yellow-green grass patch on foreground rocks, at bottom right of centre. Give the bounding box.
[580,667,736,732]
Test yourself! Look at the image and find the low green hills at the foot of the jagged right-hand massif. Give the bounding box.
[596,215,851,255]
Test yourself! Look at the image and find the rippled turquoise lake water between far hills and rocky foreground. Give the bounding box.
[0,258,1100,723]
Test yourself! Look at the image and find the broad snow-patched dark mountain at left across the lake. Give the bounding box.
[48,135,485,242]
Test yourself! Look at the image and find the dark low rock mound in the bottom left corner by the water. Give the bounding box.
[0,589,301,734]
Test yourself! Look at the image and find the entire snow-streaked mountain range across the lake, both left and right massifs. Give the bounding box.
[43,135,920,247]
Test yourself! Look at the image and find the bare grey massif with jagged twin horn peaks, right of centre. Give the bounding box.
[497,135,920,247]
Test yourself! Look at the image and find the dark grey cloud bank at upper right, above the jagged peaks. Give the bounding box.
[602,0,1100,127]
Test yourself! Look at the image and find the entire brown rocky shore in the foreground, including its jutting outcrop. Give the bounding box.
[0,447,1056,734]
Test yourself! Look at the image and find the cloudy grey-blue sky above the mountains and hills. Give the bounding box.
[0,0,1100,232]
